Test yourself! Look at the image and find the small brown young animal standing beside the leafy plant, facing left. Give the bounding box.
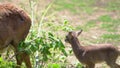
[66,31,120,68]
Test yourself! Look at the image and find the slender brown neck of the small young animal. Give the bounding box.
[70,38,84,53]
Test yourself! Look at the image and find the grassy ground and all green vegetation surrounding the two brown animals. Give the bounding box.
[0,0,120,68]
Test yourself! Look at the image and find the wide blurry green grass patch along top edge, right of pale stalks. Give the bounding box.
[53,0,95,14]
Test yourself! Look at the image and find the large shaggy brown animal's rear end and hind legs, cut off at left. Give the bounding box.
[0,3,32,68]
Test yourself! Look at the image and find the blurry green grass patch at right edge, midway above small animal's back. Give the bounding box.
[98,15,120,32]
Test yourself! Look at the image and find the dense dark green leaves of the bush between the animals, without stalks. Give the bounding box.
[19,32,67,66]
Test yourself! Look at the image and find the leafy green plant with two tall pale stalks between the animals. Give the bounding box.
[18,1,67,68]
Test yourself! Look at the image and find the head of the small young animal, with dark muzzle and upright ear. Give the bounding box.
[65,30,82,43]
